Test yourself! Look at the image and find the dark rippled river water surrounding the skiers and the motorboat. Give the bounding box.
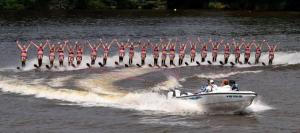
[0,11,300,133]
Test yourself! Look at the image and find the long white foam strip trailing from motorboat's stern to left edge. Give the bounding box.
[0,80,203,114]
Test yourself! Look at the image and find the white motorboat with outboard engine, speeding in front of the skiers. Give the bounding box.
[168,81,257,112]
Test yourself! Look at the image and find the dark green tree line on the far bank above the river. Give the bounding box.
[0,0,300,11]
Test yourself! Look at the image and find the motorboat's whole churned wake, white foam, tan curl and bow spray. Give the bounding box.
[0,61,274,115]
